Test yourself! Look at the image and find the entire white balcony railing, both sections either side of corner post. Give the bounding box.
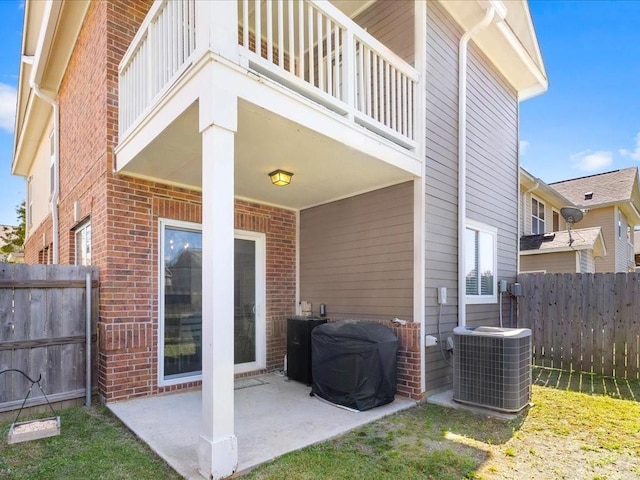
[119,0,418,151]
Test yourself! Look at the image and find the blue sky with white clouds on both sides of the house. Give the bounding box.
[0,0,640,224]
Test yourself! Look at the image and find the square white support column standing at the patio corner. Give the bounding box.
[198,83,238,479]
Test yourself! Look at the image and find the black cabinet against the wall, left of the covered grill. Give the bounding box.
[287,317,327,386]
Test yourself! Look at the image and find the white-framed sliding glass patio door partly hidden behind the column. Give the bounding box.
[159,220,266,385]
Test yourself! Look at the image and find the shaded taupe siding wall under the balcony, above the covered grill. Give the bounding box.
[300,182,413,319]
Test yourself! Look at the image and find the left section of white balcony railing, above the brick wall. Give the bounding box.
[118,0,196,134]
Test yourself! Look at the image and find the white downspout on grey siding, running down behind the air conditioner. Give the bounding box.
[458,6,496,327]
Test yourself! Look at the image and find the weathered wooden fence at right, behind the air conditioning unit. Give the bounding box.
[518,273,640,379]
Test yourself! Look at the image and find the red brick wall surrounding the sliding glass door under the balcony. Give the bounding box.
[98,177,296,400]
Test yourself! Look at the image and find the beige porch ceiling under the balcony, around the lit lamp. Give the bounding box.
[121,100,412,209]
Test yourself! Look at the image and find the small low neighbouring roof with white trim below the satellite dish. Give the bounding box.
[520,227,607,257]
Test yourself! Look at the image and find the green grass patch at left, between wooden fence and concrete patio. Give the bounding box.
[0,407,181,480]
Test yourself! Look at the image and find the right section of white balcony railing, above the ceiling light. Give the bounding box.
[238,0,418,147]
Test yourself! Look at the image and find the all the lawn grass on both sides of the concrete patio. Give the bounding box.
[0,369,640,480]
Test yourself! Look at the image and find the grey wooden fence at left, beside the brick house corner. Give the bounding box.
[0,263,98,412]
